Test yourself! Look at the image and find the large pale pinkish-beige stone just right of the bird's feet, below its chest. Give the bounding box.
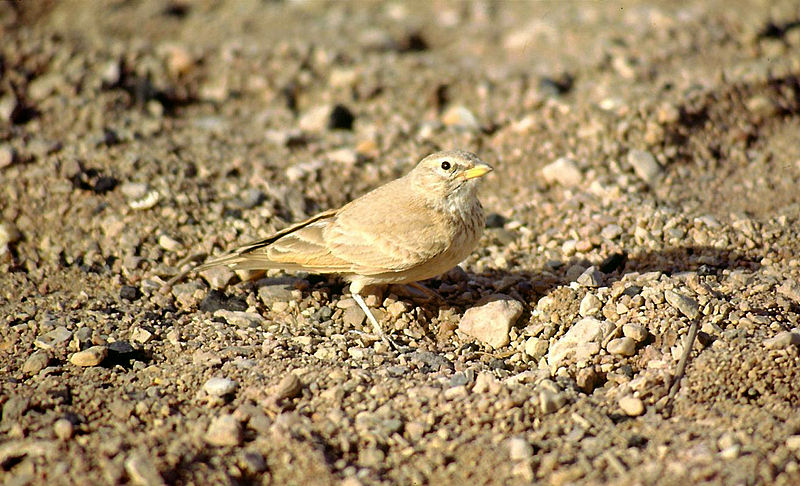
[458,294,522,348]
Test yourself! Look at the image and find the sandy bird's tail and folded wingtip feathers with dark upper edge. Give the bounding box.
[196,210,352,273]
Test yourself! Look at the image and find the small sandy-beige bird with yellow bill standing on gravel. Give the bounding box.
[195,150,493,348]
